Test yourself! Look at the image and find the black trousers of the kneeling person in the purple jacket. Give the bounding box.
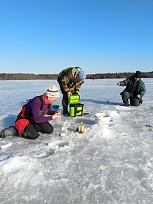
[21,122,53,139]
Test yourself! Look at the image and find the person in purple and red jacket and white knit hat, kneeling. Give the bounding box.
[15,85,61,139]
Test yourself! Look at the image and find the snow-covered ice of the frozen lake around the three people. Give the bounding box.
[0,79,153,204]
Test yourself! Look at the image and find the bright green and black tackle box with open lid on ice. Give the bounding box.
[69,94,84,117]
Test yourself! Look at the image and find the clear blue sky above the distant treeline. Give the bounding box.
[0,0,153,74]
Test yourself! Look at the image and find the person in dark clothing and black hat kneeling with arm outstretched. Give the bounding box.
[117,71,146,106]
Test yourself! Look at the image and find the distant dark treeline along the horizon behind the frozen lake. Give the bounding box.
[0,71,153,80]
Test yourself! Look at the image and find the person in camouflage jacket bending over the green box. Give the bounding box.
[57,67,86,116]
